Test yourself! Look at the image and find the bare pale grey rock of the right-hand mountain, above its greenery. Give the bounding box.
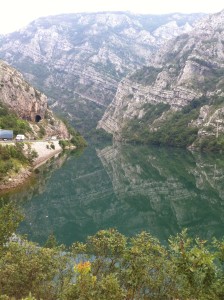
[98,11,224,145]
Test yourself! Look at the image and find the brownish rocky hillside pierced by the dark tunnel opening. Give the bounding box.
[0,61,69,139]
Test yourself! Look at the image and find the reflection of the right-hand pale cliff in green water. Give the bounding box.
[97,144,224,239]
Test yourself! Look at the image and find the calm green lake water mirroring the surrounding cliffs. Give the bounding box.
[3,144,224,245]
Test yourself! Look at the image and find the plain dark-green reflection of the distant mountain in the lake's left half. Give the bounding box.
[20,147,116,244]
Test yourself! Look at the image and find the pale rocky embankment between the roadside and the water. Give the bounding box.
[0,141,62,192]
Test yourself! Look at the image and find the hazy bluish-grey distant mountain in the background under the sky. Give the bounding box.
[0,12,202,134]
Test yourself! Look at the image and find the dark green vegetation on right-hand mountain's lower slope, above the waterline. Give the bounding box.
[122,97,208,147]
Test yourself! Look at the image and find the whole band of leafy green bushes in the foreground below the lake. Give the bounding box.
[0,199,224,300]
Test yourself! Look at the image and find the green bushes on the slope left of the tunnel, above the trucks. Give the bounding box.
[0,102,32,135]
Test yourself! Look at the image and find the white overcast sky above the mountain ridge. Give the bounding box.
[0,0,224,33]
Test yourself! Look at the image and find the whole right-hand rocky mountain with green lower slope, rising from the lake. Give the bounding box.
[98,11,224,150]
